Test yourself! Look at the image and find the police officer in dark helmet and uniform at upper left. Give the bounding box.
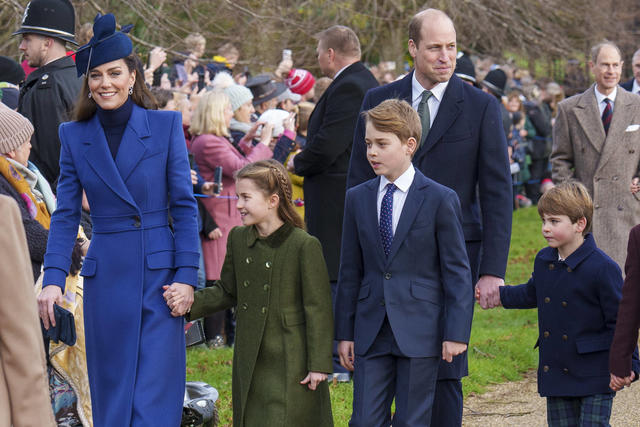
[13,0,81,184]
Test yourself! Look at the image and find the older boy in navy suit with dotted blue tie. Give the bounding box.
[335,99,473,427]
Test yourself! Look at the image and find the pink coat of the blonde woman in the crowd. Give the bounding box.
[191,134,273,280]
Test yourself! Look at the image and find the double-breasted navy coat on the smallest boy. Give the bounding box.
[500,234,636,397]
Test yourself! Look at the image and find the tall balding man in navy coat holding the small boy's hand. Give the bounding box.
[347,9,512,427]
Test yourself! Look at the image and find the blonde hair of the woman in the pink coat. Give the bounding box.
[189,90,231,136]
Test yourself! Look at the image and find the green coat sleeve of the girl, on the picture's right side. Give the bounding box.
[299,238,333,373]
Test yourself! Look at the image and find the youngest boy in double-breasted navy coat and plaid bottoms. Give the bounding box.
[476,182,638,427]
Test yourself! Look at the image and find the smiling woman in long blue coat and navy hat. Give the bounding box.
[38,14,198,427]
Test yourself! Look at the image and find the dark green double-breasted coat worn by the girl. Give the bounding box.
[190,224,333,427]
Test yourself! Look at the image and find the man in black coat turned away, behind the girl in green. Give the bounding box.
[289,25,378,380]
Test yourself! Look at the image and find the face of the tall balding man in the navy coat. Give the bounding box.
[409,17,457,89]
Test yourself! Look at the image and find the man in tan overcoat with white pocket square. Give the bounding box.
[551,41,640,269]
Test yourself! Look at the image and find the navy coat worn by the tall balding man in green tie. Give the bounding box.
[347,73,513,277]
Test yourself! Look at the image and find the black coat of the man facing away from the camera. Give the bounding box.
[294,62,378,281]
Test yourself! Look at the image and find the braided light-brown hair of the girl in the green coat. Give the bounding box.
[236,159,305,230]
